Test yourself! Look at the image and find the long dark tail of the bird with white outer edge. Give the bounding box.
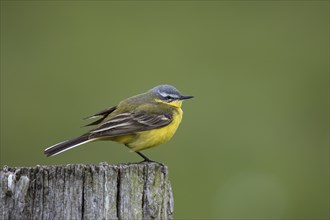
[44,135,95,157]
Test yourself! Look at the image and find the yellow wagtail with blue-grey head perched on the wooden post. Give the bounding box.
[44,85,193,161]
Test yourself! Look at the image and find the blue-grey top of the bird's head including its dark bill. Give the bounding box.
[149,85,193,102]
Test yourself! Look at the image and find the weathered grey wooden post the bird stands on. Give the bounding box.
[0,163,173,220]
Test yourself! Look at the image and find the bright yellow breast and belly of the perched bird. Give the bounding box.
[127,108,182,151]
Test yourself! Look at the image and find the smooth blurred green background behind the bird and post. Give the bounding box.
[1,1,329,219]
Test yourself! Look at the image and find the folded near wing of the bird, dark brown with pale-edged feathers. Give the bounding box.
[89,112,172,138]
